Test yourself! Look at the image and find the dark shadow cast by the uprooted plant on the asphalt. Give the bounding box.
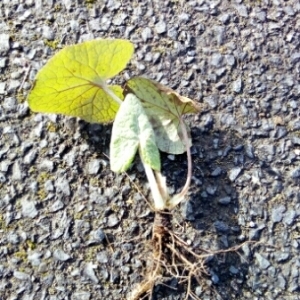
[78,118,254,299]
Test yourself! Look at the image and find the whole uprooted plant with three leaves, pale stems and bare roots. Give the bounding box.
[28,40,246,300]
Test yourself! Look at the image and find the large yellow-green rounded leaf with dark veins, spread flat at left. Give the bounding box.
[28,39,133,123]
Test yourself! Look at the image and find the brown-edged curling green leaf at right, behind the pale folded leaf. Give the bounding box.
[124,77,200,154]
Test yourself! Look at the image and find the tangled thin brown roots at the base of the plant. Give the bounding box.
[128,212,257,300]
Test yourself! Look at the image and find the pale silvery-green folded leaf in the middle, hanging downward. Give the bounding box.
[110,94,160,173]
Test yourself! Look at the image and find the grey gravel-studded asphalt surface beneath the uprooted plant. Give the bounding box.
[0,0,300,300]
